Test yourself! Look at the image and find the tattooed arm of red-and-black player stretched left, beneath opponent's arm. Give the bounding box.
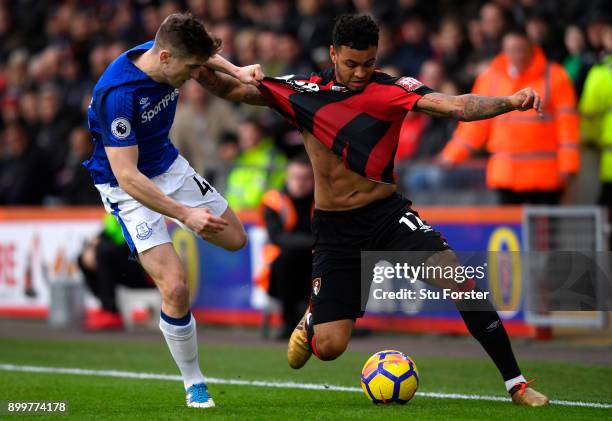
[196,67,268,105]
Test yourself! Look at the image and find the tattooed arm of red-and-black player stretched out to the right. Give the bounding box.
[415,88,542,121]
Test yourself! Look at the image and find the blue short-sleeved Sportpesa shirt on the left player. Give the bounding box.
[83,41,179,186]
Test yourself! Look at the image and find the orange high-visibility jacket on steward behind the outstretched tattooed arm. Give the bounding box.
[442,47,580,192]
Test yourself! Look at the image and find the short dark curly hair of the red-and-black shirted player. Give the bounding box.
[332,15,378,50]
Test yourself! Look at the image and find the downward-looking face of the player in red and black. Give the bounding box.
[329,45,378,91]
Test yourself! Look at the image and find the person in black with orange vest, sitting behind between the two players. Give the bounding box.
[255,155,314,338]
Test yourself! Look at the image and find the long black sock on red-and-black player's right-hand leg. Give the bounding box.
[456,287,521,381]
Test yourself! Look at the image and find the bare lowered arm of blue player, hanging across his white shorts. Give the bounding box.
[104,145,228,236]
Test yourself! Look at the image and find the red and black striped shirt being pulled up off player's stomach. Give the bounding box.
[259,70,433,184]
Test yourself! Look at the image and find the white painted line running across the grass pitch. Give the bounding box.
[0,364,612,409]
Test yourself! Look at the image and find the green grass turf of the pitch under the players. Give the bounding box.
[0,339,612,420]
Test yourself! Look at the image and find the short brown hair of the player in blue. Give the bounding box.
[155,13,221,59]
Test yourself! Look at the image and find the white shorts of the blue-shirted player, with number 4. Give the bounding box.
[96,155,227,253]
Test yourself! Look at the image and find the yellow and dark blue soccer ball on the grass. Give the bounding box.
[361,350,419,404]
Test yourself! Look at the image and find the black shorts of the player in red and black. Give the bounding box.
[310,193,450,324]
